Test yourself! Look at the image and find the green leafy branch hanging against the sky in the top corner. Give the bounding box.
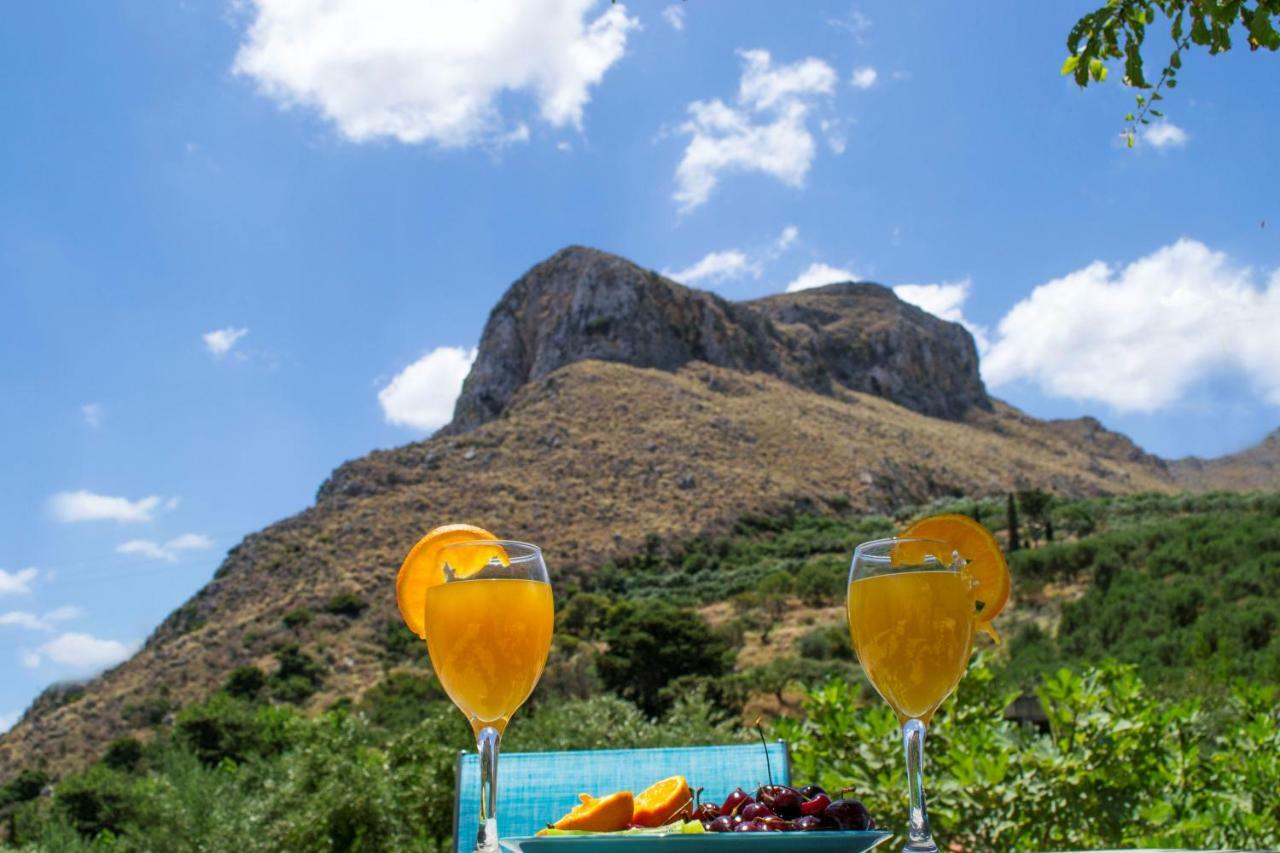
[1062,0,1280,147]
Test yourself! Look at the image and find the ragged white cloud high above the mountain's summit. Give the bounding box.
[675,50,836,211]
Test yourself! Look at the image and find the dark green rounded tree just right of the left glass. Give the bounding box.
[598,602,732,717]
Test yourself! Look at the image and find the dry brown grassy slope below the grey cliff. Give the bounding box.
[0,361,1175,779]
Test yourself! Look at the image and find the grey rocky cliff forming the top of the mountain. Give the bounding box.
[445,247,991,434]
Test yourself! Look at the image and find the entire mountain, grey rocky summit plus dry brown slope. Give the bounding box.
[0,244,1274,779]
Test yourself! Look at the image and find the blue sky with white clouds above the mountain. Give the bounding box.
[0,0,1280,729]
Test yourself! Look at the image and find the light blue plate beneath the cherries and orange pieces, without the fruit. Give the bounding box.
[502,833,892,853]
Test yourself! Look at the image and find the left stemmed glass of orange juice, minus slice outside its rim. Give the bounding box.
[425,539,554,853]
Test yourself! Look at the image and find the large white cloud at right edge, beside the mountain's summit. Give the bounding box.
[983,240,1280,412]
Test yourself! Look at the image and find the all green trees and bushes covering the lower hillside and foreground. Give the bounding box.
[0,492,1280,850]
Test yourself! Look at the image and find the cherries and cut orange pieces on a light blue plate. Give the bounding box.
[502,776,891,853]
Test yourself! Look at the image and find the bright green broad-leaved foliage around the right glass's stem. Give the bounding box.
[778,653,1280,850]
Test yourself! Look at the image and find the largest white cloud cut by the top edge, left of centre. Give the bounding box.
[234,0,639,146]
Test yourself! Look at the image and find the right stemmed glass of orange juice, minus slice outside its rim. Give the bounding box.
[847,538,975,853]
